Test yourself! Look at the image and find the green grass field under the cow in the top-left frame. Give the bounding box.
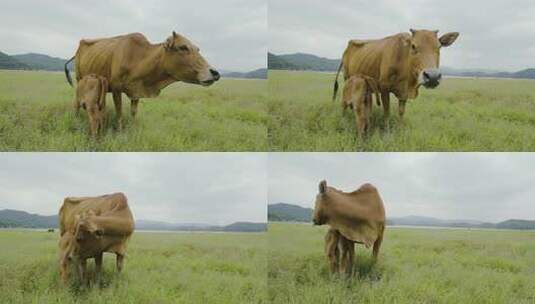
[0,71,268,151]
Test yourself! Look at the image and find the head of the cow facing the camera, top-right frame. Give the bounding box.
[410,29,459,88]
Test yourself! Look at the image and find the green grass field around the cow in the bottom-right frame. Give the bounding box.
[268,224,535,304]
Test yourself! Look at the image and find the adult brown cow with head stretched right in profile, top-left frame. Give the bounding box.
[65,32,220,128]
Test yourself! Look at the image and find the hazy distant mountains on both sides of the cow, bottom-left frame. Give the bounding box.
[0,209,267,232]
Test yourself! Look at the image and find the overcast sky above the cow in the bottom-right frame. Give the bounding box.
[268,153,535,222]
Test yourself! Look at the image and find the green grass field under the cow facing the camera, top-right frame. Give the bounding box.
[268,71,535,151]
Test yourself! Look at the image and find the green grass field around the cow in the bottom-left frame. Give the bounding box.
[0,230,267,304]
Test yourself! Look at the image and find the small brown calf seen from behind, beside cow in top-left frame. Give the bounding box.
[74,74,108,137]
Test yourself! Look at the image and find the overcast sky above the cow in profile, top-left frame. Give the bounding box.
[0,0,268,71]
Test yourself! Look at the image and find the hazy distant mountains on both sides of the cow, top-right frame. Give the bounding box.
[268,53,535,79]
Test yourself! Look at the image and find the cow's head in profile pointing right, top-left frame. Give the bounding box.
[163,32,220,86]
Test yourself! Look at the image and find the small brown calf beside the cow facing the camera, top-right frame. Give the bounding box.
[342,75,381,137]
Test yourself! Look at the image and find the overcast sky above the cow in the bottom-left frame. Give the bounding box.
[0,153,267,225]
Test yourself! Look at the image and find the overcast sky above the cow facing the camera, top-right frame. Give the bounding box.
[268,0,535,70]
